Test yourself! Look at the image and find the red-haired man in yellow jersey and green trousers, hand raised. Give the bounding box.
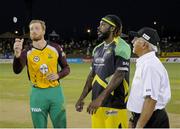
[13,20,70,128]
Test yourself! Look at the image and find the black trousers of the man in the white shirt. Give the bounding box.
[132,109,170,128]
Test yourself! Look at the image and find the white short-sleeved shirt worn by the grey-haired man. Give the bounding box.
[127,52,171,113]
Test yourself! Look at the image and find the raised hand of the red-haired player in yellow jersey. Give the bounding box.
[14,38,24,58]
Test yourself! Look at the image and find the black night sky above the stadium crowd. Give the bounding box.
[0,0,180,38]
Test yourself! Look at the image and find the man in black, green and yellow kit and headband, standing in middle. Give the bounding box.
[75,15,131,128]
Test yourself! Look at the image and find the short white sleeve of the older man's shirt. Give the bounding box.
[142,66,160,100]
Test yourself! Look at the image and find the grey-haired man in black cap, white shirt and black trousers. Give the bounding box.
[127,27,171,128]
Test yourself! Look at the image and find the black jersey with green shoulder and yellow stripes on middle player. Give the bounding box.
[92,37,131,109]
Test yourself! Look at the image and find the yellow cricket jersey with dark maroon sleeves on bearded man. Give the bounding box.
[13,43,69,88]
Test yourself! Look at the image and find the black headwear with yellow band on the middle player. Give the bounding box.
[101,14,122,28]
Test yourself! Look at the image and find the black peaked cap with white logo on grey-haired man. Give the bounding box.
[129,27,160,46]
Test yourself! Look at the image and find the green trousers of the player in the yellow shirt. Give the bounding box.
[30,86,66,128]
